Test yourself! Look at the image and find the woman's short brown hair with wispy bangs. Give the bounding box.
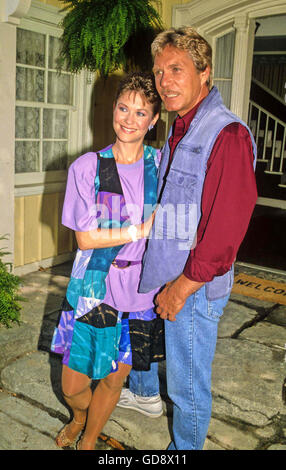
[115,72,161,116]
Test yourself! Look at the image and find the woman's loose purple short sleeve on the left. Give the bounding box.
[62,152,97,232]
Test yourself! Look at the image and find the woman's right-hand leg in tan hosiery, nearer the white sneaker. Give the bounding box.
[79,363,131,450]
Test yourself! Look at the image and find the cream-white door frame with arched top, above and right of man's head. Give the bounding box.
[172,0,286,121]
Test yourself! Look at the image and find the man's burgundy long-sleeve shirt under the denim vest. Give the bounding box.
[166,103,257,282]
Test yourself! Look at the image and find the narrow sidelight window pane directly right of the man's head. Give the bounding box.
[214,31,235,108]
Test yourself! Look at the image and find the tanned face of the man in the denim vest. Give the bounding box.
[153,46,210,116]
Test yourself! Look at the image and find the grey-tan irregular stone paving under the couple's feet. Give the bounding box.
[0,263,286,450]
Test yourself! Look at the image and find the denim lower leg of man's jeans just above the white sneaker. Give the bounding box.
[129,362,159,397]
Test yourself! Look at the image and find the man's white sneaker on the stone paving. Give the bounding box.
[117,388,163,418]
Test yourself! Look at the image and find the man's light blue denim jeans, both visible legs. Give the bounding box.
[130,286,229,450]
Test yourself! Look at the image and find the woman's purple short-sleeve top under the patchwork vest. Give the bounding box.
[62,148,158,312]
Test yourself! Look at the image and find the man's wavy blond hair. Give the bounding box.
[151,26,212,89]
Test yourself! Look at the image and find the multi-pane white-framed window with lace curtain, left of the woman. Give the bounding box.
[15,28,74,176]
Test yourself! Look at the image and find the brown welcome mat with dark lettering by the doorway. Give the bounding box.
[232,273,286,305]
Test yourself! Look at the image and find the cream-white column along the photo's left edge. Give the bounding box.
[0,0,30,263]
